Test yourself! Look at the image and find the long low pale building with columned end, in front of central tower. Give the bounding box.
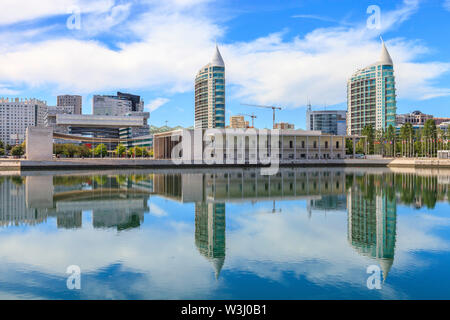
[153,129,360,164]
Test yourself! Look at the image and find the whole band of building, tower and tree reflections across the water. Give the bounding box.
[0,168,450,278]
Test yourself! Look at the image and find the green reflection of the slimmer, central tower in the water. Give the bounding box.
[195,202,225,279]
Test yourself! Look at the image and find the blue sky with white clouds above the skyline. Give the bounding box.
[0,0,450,128]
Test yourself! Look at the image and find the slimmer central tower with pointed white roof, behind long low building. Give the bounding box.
[195,45,225,129]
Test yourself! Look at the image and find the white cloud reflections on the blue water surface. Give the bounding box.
[0,202,450,299]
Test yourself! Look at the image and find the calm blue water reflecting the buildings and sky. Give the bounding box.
[0,168,450,299]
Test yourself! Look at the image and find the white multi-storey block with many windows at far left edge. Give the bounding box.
[0,98,47,145]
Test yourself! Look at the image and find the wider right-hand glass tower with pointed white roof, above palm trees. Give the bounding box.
[347,40,397,134]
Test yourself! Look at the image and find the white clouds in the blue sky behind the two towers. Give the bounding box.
[0,0,450,111]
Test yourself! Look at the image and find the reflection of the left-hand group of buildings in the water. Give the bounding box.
[0,176,150,231]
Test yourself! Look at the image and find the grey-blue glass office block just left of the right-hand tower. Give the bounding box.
[306,107,347,135]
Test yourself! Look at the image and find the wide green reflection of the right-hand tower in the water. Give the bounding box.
[347,187,397,280]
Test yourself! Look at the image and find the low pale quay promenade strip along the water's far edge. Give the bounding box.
[0,158,450,171]
